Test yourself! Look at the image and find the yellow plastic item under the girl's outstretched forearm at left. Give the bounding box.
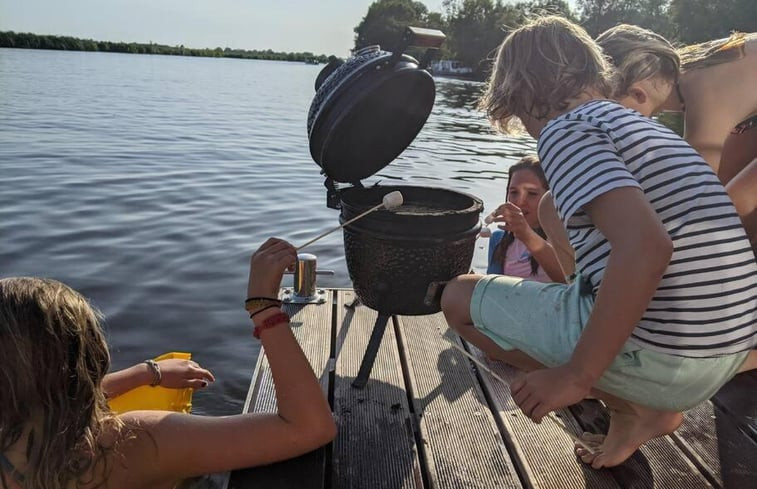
[108,352,194,414]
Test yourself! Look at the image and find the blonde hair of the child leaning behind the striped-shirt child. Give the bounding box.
[597,24,681,98]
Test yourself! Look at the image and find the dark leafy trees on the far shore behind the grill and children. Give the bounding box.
[354,0,757,77]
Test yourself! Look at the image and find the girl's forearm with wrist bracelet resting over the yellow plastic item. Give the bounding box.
[102,358,215,399]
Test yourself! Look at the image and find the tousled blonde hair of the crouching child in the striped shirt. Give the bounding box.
[479,15,611,133]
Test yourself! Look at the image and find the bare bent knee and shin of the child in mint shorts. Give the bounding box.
[442,274,544,370]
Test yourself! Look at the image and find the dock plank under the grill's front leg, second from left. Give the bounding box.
[332,291,424,489]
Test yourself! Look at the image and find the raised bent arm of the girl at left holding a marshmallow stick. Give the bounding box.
[121,238,336,482]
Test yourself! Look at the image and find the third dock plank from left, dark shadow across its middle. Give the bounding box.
[398,313,522,489]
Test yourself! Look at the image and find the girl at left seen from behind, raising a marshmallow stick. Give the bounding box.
[0,238,336,489]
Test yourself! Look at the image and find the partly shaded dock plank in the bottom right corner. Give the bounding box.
[671,393,757,489]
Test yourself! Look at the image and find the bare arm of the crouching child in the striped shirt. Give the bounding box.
[512,187,673,422]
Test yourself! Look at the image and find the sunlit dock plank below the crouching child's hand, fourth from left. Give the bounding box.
[467,344,624,489]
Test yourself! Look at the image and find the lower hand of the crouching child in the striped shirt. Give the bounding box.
[510,365,591,423]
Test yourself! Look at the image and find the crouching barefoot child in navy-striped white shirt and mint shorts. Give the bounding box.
[442,16,757,469]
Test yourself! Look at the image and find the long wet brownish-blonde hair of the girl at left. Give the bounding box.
[0,277,121,489]
